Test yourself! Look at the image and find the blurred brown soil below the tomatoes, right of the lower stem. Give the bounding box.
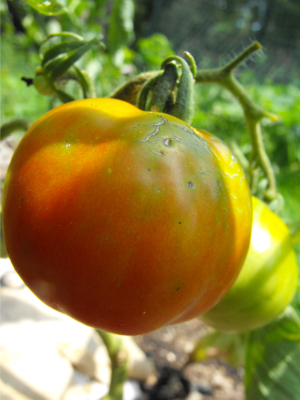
[134,319,245,400]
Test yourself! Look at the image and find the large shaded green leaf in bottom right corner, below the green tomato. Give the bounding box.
[245,290,300,400]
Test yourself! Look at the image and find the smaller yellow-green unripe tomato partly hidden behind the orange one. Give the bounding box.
[200,197,298,333]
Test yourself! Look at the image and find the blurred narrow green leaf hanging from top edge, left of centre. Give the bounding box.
[107,0,134,53]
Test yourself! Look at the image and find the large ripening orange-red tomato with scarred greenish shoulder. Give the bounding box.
[3,99,252,335]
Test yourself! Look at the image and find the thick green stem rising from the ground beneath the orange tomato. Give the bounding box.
[97,330,127,400]
